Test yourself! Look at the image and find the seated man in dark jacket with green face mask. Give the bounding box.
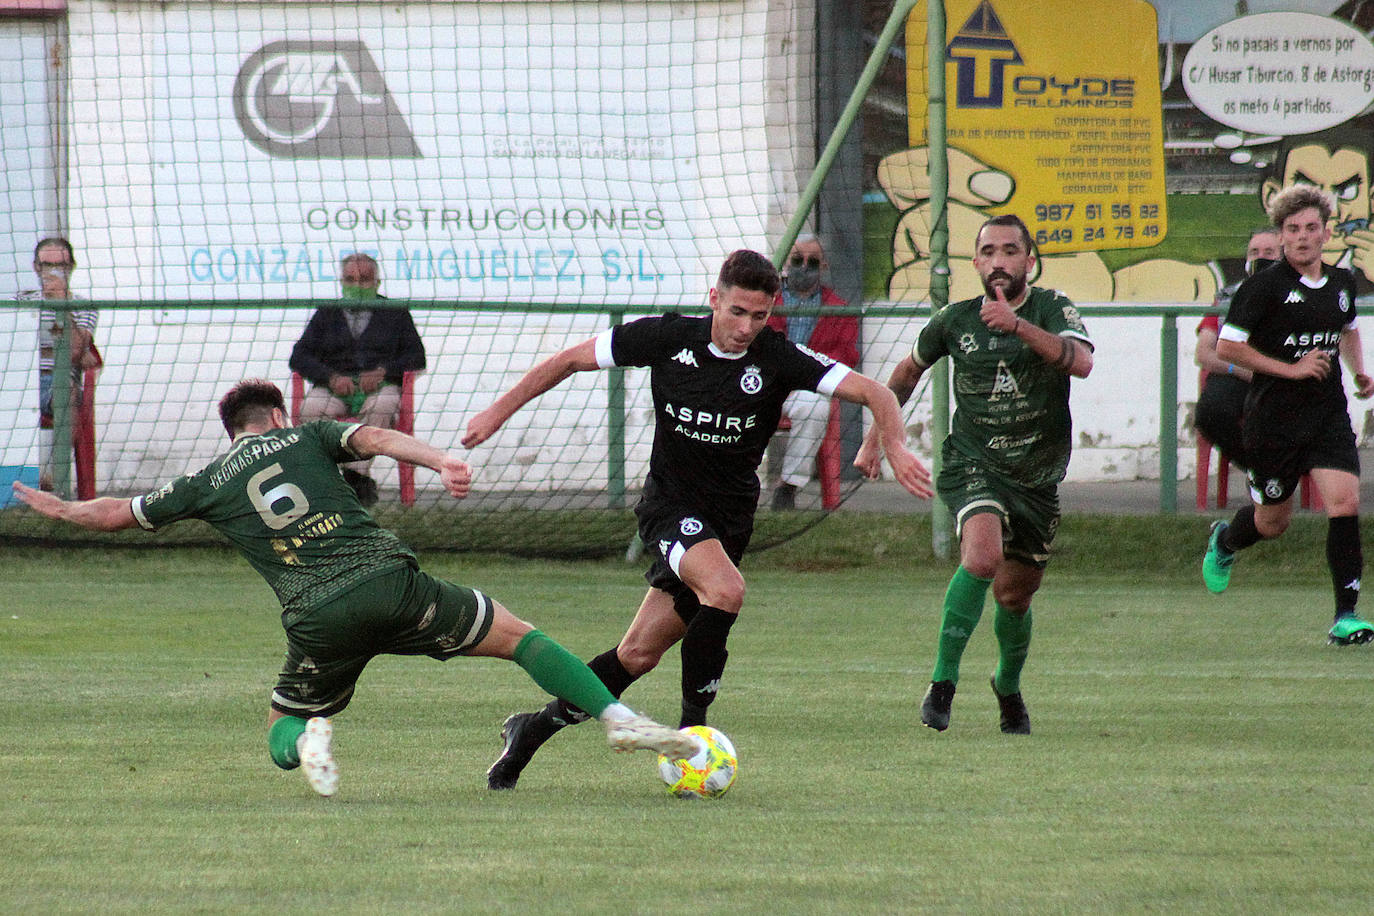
[291,254,425,505]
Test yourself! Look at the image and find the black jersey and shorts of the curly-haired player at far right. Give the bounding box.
[1220,260,1355,444]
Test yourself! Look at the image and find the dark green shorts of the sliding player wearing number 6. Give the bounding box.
[272,567,493,718]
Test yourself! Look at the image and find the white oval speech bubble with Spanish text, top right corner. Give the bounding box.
[1183,12,1374,135]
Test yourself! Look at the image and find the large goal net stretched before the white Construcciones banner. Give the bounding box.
[0,0,890,555]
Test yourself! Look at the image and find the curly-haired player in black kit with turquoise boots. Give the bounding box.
[1202,184,1374,645]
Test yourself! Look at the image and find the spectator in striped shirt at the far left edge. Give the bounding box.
[16,236,102,490]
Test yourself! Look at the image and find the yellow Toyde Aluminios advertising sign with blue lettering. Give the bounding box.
[907,0,1168,254]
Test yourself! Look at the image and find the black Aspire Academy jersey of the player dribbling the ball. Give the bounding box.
[596,313,851,518]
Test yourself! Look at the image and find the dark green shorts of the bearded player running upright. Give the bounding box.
[936,449,1059,570]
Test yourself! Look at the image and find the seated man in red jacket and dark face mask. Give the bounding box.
[768,235,859,509]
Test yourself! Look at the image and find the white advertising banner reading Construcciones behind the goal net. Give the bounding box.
[71,0,786,305]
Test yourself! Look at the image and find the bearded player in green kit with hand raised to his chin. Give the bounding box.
[855,214,1092,735]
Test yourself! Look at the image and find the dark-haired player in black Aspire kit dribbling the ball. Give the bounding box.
[463,250,930,788]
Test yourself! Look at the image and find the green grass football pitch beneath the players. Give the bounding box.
[0,518,1374,913]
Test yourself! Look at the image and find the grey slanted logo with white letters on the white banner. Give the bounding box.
[234,41,420,159]
